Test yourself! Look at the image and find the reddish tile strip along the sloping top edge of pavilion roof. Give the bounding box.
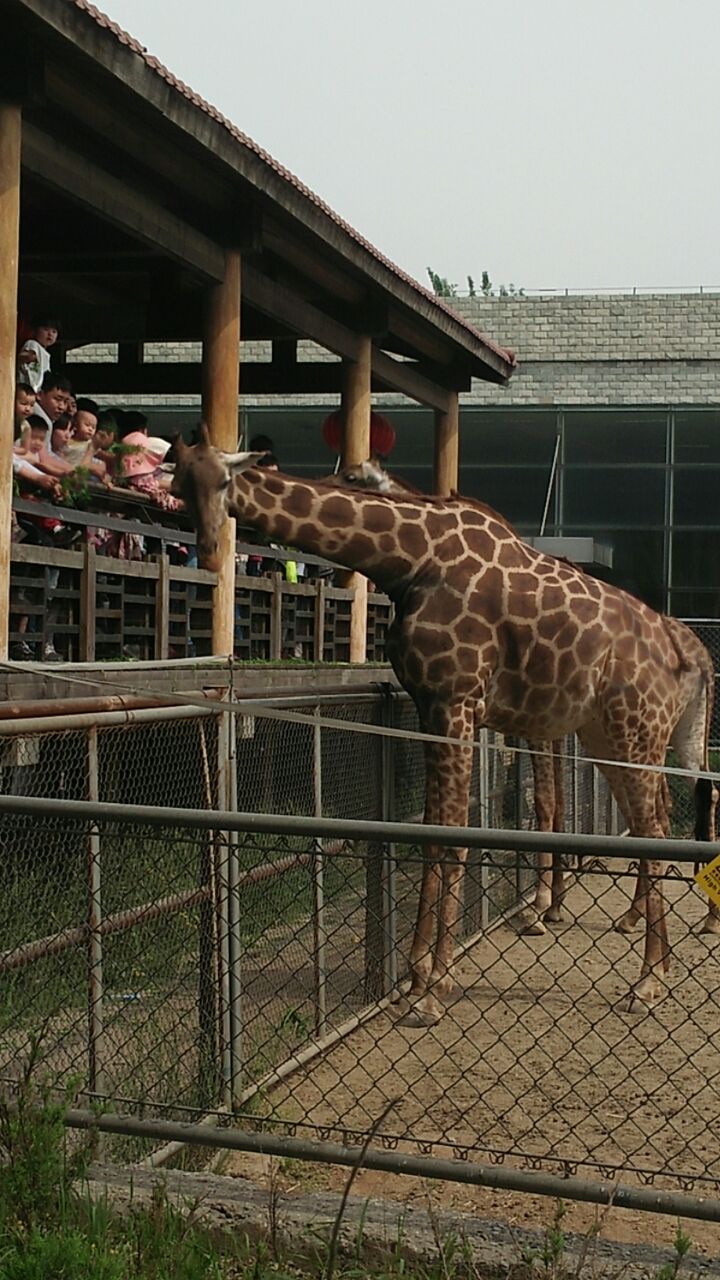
[68,0,516,366]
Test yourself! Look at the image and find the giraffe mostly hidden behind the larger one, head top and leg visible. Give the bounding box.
[328,456,568,937]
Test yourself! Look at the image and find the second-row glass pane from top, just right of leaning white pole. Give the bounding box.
[562,467,665,526]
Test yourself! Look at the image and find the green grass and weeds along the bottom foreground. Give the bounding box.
[0,1043,691,1280]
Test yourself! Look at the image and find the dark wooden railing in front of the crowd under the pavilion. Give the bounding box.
[9,503,392,662]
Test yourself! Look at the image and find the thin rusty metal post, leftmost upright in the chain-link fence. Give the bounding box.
[87,728,105,1093]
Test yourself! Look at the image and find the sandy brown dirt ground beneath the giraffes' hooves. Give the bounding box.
[223,872,720,1256]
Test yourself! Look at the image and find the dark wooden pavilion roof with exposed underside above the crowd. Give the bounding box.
[0,0,515,408]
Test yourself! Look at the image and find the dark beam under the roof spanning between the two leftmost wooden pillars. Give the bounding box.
[23,124,224,282]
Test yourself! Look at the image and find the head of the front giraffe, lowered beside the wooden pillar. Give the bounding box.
[172,424,263,564]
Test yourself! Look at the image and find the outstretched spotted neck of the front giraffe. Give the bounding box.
[227,467,432,590]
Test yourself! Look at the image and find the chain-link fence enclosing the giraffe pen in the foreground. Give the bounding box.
[0,691,720,1208]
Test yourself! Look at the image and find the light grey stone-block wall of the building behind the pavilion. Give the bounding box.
[68,293,720,407]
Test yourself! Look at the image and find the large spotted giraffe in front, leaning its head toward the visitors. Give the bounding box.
[173,428,720,1027]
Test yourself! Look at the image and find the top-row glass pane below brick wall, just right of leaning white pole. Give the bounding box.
[565,408,667,463]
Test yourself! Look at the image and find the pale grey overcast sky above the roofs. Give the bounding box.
[97,0,720,289]
